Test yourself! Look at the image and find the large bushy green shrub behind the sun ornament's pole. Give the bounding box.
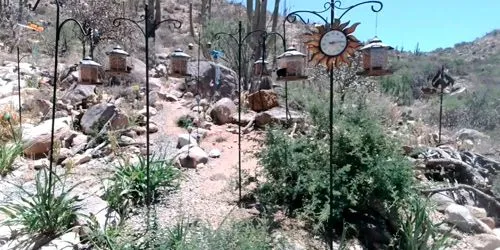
[257,103,413,230]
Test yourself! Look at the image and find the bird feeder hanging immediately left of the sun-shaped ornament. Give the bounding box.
[276,46,307,81]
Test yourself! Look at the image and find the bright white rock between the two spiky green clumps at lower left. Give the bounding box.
[80,195,121,232]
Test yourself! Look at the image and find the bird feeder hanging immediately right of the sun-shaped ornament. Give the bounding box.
[359,36,394,76]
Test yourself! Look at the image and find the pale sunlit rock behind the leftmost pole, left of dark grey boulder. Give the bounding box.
[22,117,71,156]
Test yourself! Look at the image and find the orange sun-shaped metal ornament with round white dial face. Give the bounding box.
[304,19,361,70]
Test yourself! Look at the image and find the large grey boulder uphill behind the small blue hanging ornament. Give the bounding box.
[186,61,238,100]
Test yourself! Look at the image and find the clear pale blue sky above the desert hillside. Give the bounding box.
[268,0,500,52]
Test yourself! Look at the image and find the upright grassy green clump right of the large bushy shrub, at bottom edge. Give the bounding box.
[392,196,451,250]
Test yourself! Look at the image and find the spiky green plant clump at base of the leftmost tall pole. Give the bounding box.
[0,169,81,238]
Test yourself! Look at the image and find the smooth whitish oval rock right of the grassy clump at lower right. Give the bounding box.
[445,204,478,233]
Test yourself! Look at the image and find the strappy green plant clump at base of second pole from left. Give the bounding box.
[104,156,180,217]
